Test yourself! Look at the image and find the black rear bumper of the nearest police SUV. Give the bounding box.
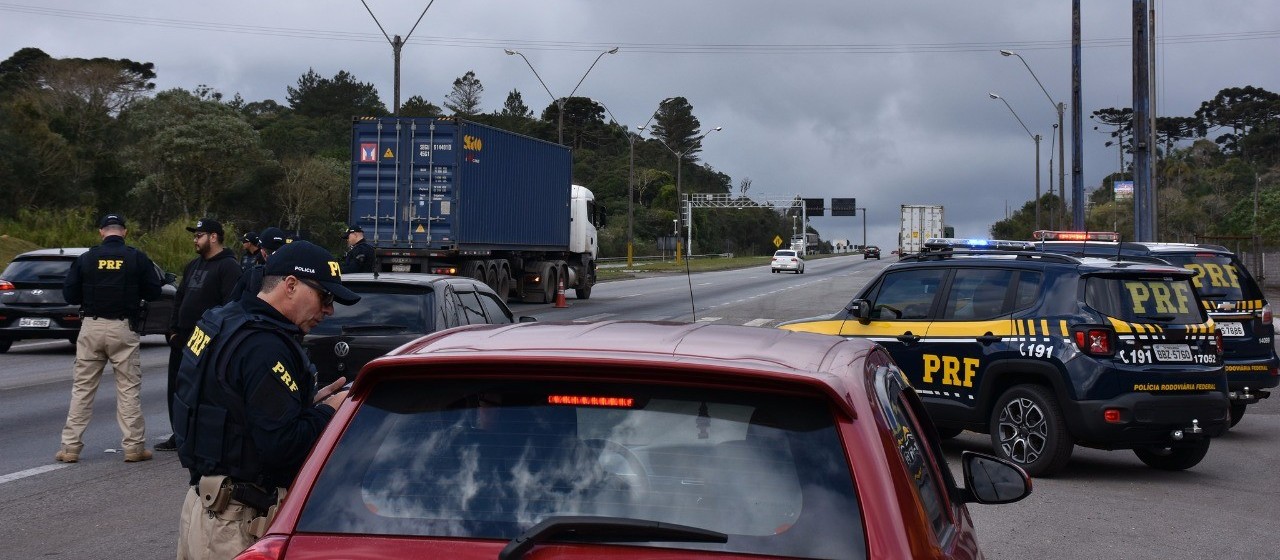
[1062,393,1230,449]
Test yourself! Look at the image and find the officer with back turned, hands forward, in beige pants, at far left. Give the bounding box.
[54,214,164,463]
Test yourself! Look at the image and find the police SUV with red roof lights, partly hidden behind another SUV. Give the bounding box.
[1034,230,1280,426]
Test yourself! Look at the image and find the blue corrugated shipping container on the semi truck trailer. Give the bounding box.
[349,118,572,251]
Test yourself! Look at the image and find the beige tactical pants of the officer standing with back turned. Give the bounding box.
[63,317,146,453]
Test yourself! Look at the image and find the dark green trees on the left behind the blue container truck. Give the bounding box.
[0,47,808,270]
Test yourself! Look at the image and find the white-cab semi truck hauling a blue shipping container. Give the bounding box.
[349,118,603,303]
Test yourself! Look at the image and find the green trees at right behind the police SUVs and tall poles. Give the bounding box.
[991,86,1280,247]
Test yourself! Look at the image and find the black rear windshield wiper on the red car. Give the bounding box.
[498,515,728,560]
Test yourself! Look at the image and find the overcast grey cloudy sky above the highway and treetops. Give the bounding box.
[0,0,1280,247]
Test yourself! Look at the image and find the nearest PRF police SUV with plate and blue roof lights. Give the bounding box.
[780,239,1229,476]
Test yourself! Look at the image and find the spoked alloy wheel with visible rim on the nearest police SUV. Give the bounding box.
[991,385,1075,477]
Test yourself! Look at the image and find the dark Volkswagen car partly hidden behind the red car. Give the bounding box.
[302,272,524,386]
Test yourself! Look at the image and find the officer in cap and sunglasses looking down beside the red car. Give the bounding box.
[173,242,360,559]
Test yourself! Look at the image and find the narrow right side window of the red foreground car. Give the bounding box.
[876,366,951,541]
